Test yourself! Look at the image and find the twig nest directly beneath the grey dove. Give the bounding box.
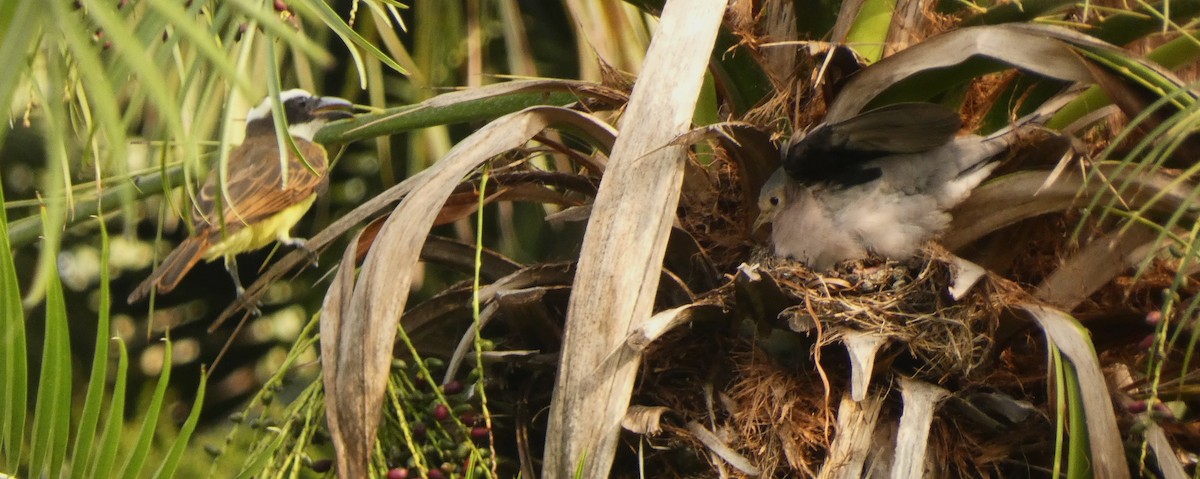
[763,249,1001,383]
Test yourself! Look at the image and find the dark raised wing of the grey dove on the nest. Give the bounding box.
[782,103,961,186]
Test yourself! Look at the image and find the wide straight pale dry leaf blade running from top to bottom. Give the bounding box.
[542,0,726,478]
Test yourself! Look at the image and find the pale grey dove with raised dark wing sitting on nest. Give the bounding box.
[754,102,1015,271]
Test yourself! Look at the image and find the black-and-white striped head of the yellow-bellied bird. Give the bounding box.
[246,88,354,142]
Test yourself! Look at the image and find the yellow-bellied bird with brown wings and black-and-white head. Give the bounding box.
[127,89,353,304]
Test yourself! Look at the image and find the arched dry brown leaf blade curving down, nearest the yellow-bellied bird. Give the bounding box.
[322,107,613,478]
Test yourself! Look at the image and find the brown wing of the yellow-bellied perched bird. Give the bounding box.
[193,139,329,234]
